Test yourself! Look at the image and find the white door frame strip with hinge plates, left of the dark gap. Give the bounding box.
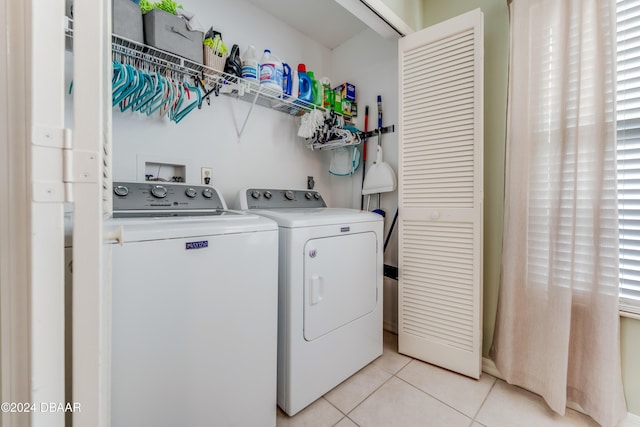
[24,0,67,427]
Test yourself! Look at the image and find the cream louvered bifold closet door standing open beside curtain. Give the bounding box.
[398,10,483,378]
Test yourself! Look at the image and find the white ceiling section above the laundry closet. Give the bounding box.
[242,0,367,49]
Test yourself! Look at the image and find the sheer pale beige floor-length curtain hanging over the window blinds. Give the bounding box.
[491,0,626,426]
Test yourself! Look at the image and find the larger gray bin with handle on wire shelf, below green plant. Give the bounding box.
[144,9,204,64]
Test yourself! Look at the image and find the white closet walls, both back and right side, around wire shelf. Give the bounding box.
[62,0,398,330]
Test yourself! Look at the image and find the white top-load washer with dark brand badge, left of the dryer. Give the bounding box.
[107,183,278,427]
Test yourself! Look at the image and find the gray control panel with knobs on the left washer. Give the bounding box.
[113,182,226,217]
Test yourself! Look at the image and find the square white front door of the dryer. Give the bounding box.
[304,232,378,341]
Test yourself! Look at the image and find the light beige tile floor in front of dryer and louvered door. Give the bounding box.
[276,331,636,427]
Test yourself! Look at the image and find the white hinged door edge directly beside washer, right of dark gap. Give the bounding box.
[72,0,111,427]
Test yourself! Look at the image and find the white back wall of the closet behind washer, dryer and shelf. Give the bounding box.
[113,0,341,206]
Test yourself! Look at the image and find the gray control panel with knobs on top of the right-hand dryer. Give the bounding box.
[240,188,327,209]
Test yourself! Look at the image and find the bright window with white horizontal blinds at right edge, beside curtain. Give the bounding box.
[616,0,640,314]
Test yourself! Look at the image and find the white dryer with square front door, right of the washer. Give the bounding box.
[238,188,383,415]
